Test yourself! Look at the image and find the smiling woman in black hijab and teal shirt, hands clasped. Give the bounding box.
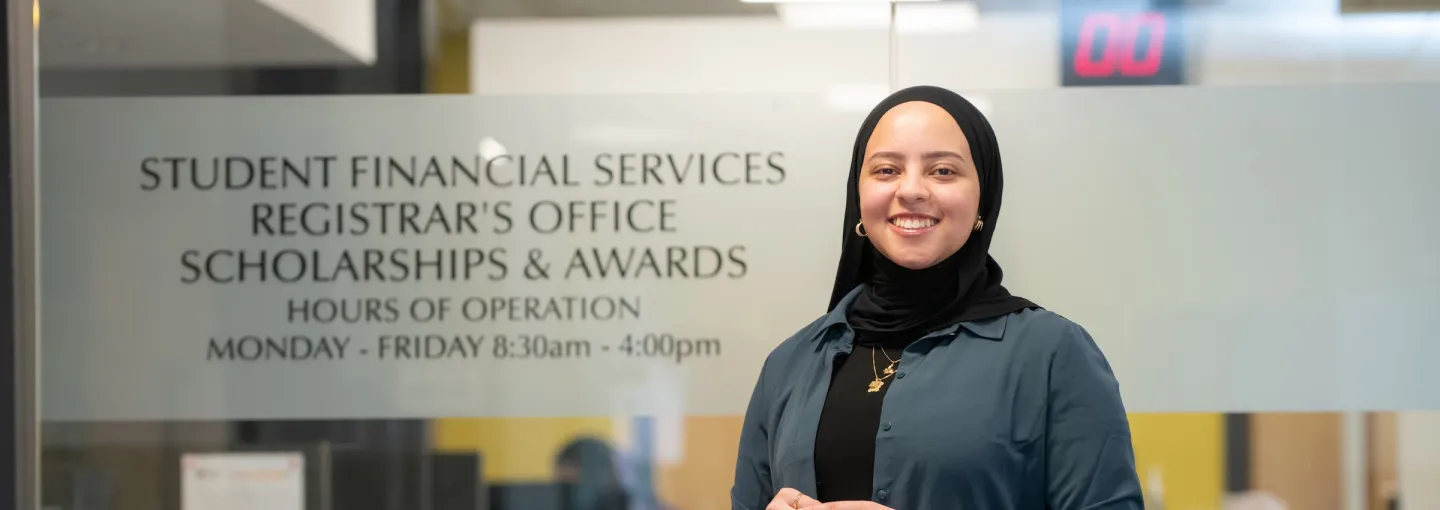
[732,86,1143,510]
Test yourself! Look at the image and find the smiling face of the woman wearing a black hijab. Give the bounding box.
[860,101,981,269]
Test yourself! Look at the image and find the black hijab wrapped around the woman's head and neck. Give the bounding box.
[829,86,1038,336]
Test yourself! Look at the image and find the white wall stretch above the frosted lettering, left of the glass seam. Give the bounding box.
[471,17,888,95]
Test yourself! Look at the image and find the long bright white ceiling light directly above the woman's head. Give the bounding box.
[775,1,979,33]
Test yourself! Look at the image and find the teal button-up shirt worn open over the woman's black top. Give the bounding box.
[730,288,1143,510]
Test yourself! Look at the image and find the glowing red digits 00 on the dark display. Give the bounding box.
[1073,13,1165,78]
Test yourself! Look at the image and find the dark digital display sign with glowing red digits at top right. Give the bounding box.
[1060,1,1185,86]
